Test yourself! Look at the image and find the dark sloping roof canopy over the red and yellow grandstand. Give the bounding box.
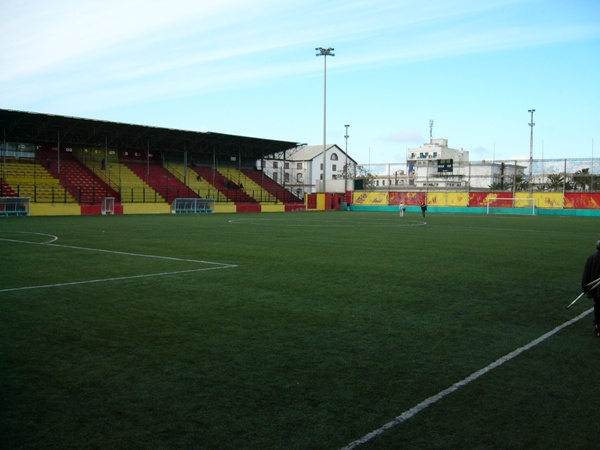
[0,109,298,160]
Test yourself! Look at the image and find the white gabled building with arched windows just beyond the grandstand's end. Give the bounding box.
[258,144,356,194]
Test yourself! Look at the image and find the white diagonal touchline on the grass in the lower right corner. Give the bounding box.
[342,308,594,450]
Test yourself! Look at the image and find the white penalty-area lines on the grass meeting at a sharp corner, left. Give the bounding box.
[0,232,237,293]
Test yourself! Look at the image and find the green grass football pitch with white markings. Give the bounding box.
[0,212,600,449]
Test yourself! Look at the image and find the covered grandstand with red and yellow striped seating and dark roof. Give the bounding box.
[0,110,303,213]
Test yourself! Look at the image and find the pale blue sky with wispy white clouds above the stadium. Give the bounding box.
[0,0,600,164]
